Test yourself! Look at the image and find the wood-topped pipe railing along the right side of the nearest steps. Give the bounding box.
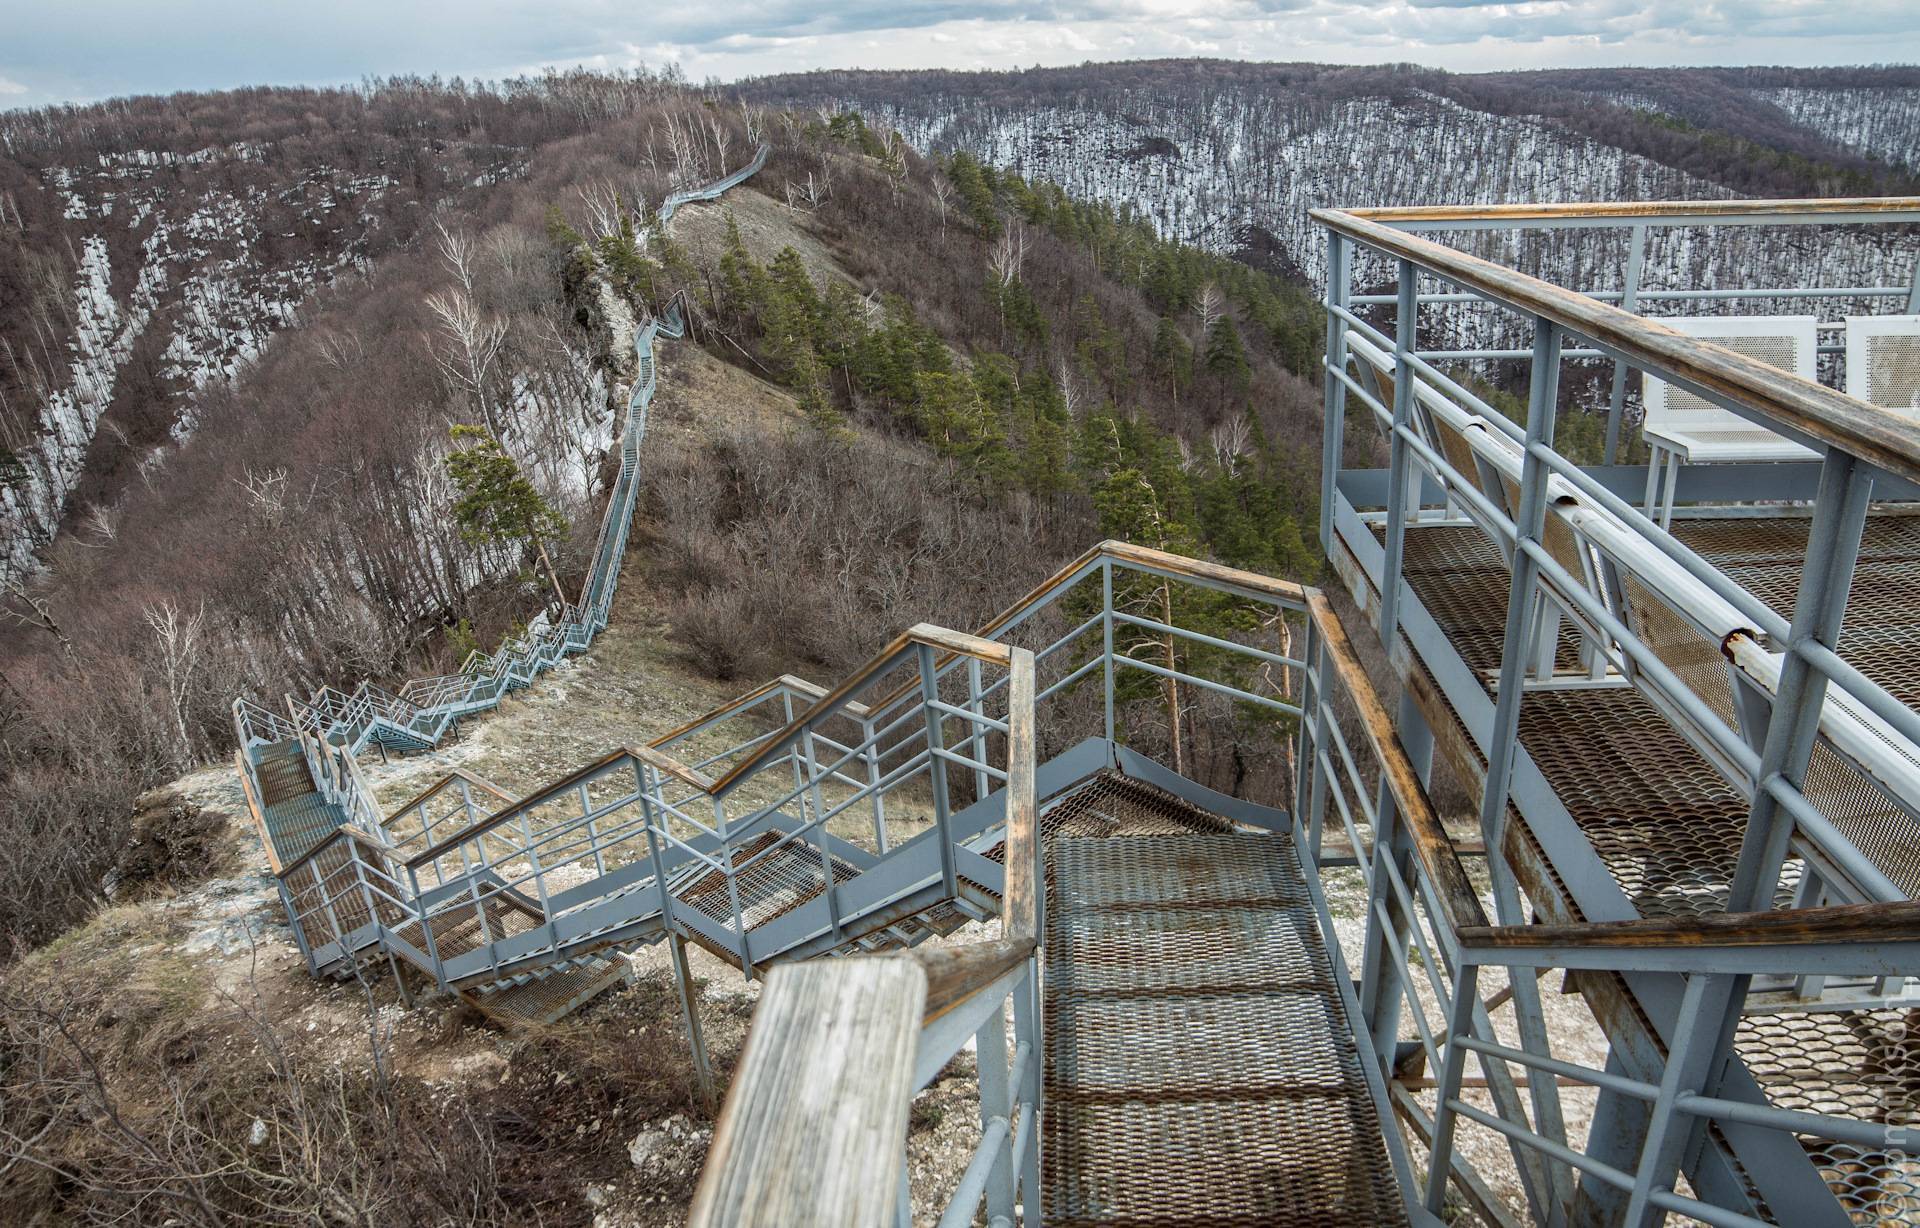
[1296,595,1920,1224]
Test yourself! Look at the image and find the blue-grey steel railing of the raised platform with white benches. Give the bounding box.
[1304,201,1920,1222]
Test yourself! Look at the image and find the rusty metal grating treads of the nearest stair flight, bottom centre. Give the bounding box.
[1043,813,1405,1228]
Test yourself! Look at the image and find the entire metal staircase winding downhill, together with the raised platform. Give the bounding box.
[236,158,1920,1228]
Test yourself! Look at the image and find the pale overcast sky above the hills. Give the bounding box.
[0,0,1920,107]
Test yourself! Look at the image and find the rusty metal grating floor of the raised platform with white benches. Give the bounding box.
[1367,516,1920,1224]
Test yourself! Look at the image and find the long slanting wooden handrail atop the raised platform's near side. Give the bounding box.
[1311,203,1920,482]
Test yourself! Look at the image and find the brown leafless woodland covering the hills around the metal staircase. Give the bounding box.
[0,61,1914,1224]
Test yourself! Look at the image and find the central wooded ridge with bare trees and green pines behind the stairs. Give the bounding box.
[0,79,1321,967]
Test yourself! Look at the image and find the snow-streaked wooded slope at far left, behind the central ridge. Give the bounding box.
[0,75,683,581]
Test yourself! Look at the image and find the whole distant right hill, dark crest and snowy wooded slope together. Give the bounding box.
[743,59,1920,342]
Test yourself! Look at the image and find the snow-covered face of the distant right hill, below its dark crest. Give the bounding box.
[843,88,1920,345]
